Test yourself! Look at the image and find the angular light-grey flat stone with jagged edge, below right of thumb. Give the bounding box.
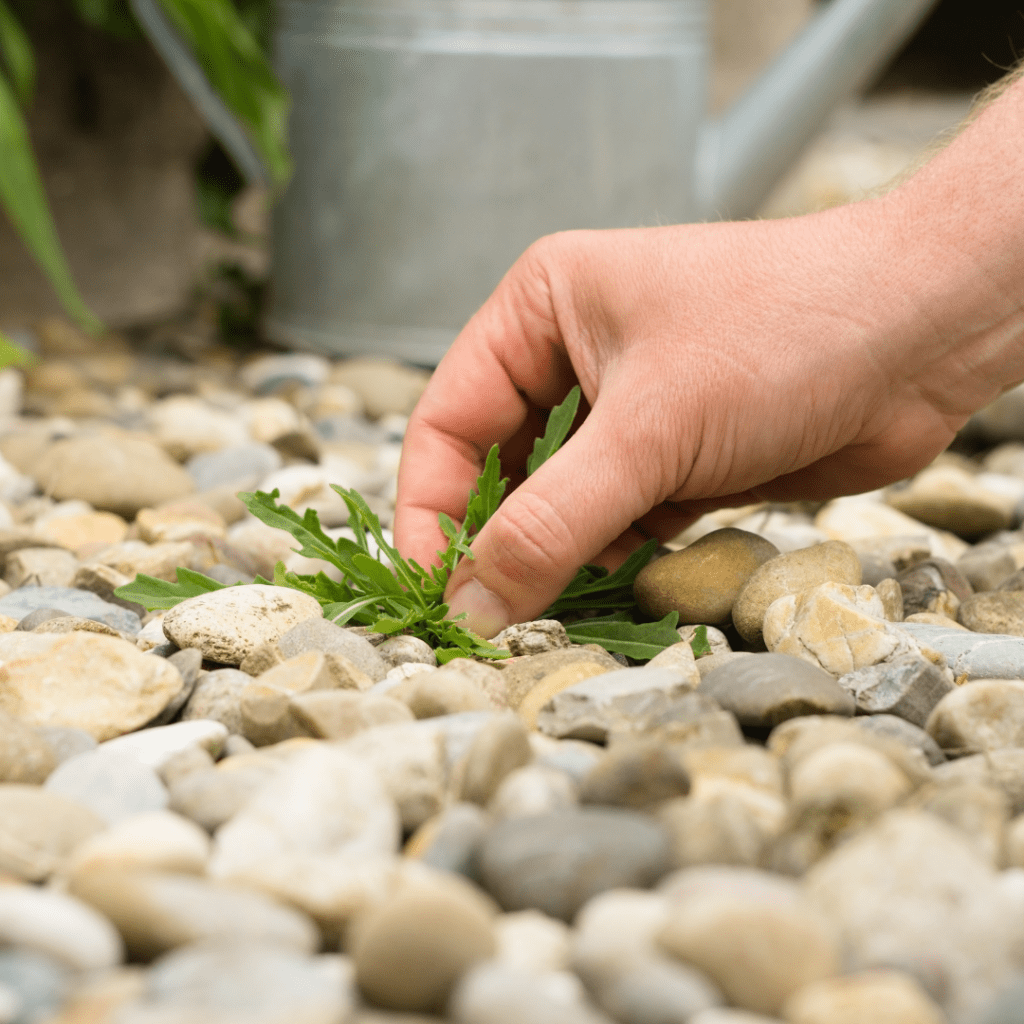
[537,669,716,742]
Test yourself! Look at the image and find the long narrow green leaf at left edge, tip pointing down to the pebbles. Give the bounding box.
[0,69,102,333]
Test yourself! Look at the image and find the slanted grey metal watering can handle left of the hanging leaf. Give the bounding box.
[130,0,270,184]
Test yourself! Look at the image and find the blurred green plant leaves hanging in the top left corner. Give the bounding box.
[0,0,291,354]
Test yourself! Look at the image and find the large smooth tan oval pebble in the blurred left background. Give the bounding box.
[29,432,195,518]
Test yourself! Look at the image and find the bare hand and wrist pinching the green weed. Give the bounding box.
[395,75,1024,637]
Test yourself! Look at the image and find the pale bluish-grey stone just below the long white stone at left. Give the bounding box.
[45,749,168,824]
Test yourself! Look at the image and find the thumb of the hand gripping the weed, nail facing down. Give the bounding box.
[445,408,656,637]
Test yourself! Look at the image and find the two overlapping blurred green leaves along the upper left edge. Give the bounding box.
[0,0,100,331]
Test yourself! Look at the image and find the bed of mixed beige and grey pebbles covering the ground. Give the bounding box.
[8,322,1024,1024]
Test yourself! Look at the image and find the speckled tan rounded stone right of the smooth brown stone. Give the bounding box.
[732,541,860,643]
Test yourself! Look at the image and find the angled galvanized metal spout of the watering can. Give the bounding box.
[695,0,935,219]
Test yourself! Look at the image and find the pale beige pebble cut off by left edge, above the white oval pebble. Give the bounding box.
[0,782,104,882]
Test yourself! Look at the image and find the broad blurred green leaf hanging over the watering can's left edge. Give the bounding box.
[160,0,292,187]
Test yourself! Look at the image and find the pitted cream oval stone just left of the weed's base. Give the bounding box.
[164,584,324,665]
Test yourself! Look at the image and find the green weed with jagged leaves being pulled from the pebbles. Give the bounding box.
[115,388,711,665]
